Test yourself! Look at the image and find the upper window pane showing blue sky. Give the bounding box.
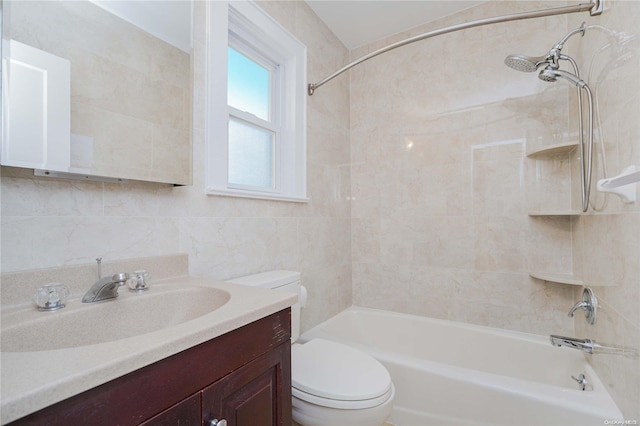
[227,47,271,120]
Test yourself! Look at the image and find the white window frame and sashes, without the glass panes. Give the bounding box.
[205,1,309,202]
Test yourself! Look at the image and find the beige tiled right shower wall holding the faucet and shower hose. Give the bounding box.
[569,1,640,420]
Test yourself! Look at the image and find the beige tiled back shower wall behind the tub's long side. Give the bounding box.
[351,2,575,335]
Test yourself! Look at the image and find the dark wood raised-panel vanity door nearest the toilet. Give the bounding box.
[202,342,291,426]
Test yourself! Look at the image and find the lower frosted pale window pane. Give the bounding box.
[229,117,274,188]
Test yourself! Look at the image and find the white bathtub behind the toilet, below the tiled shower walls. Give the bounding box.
[300,307,623,426]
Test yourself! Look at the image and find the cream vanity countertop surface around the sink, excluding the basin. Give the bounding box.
[0,277,297,424]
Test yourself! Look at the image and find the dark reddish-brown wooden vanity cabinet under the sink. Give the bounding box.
[11,309,291,426]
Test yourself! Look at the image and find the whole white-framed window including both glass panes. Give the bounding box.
[206,2,308,202]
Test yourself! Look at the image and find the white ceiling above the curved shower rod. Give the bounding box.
[306,0,484,50]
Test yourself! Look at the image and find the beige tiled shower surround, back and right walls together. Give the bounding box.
[351,1,640,419]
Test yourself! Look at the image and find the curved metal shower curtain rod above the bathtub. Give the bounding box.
[307,0,604,96]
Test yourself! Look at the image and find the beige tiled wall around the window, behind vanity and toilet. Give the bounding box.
[1,1,351,328]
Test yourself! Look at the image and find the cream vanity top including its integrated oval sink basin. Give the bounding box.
[0,276,297,424]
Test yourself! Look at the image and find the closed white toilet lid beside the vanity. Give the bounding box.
[291,339,391,405]
